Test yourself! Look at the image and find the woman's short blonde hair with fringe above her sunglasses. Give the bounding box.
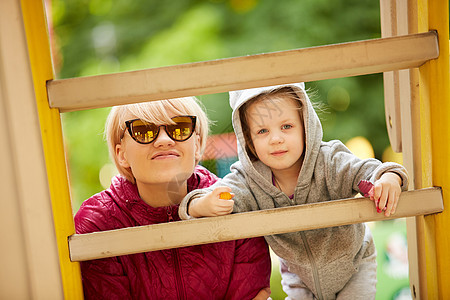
[105,97,209,183]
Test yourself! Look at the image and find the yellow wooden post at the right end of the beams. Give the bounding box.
[416,0,450,299]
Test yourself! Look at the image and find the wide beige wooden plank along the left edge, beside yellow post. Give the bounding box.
[0,0,63,299]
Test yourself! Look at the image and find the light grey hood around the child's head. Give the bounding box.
[229,82,323,190]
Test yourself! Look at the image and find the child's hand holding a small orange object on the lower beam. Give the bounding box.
[188,186,234,218]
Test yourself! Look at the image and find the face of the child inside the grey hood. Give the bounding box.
[247,96,305,171]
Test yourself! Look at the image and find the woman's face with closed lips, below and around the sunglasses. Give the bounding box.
[116,114,200,187]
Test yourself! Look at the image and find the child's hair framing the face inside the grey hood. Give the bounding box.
[239,86,303,161]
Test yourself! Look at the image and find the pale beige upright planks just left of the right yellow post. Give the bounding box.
[380,0,427,299]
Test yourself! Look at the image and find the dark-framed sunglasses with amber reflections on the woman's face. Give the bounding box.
[125,116,197,144]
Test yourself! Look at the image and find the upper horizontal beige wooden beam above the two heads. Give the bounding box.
[47,31,439,112]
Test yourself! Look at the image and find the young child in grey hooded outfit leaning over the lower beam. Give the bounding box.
[180,83,408,299]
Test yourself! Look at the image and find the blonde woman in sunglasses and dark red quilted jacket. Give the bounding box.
[75,97,270,299]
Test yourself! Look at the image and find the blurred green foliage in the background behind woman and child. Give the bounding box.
[50,0,412,299]
